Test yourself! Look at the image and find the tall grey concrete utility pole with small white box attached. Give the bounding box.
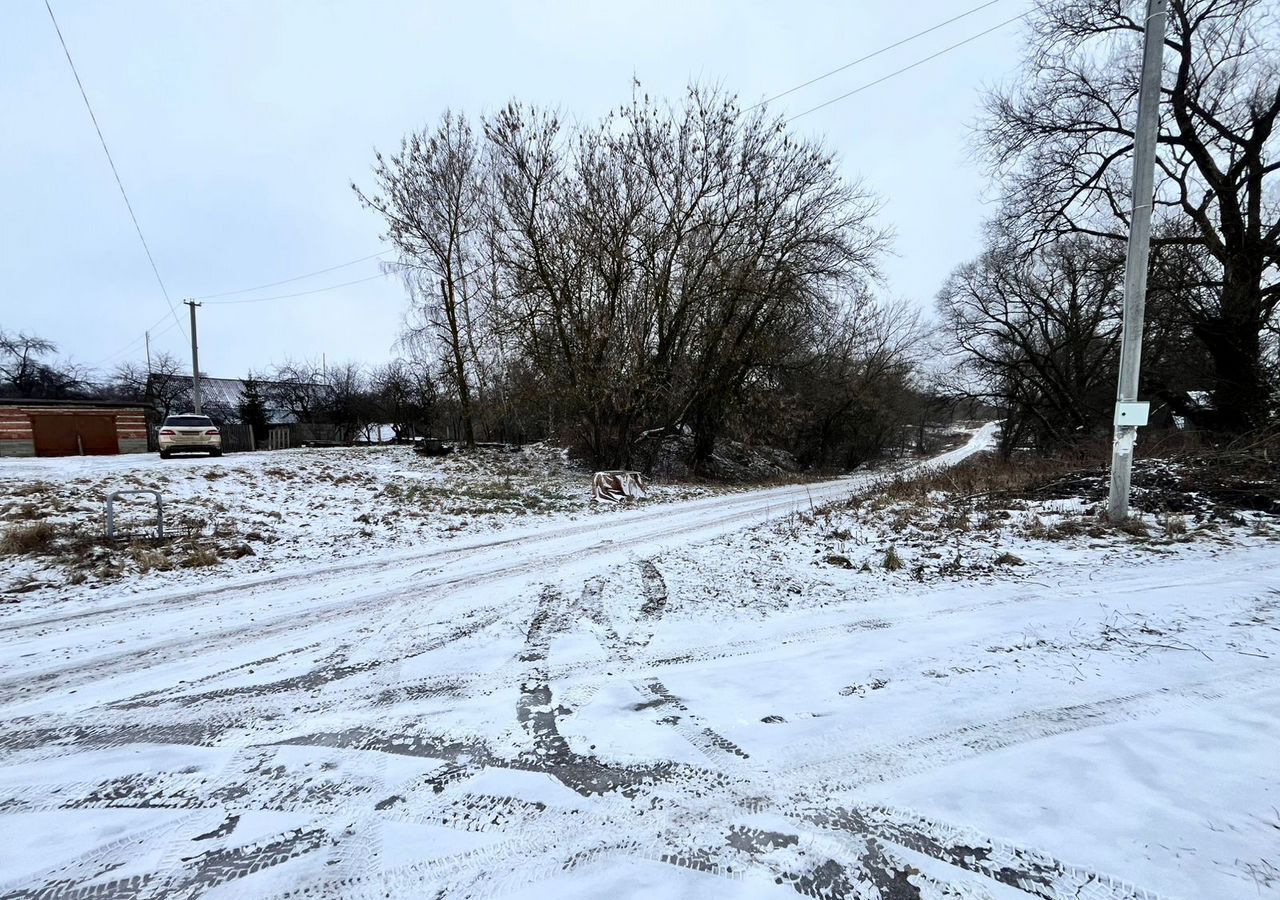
[1107,0,1167,522]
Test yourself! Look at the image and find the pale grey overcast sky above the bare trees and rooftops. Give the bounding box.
[0,0,1030,375]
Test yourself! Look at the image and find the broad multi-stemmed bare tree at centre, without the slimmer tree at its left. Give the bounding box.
[485,87,884,463]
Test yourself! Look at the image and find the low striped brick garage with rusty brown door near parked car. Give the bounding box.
[0,398,147,456]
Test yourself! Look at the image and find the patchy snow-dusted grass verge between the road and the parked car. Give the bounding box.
[0,444,724,607]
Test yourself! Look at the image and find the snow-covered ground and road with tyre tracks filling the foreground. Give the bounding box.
[0,428,1280,900]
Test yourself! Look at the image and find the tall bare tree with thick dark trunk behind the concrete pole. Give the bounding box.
[980,0,1280,430]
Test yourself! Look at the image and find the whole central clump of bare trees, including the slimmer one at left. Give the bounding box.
[357,86,921,469]
